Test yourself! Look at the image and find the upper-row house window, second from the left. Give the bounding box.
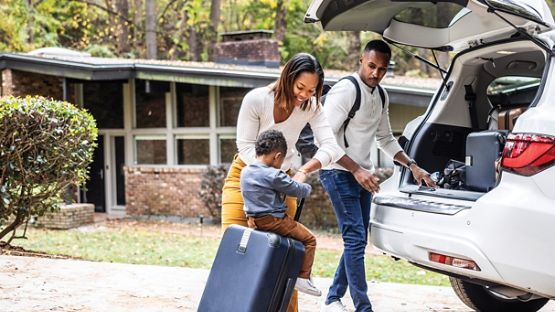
[135,79,170,128]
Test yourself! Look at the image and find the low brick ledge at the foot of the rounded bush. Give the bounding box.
[34,204,94,230]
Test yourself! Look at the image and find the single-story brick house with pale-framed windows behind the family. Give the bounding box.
[0,32,439,222]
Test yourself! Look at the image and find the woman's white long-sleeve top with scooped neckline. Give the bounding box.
[236,87,345,171]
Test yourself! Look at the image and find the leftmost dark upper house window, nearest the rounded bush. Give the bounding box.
[83,81,123,129]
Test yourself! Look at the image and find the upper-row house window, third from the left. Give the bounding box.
[176,83,210,127]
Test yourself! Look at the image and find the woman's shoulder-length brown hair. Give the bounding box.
[272,53,324,111]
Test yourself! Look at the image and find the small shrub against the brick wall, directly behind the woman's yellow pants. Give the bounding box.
[198,165,227,223]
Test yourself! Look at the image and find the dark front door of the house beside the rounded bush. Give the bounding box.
[81,134,106,212]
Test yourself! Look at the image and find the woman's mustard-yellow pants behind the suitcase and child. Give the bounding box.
[222,155,298,312]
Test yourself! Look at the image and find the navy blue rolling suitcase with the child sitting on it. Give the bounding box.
[198,199,304,312]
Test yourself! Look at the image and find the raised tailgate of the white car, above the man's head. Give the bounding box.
[305,0,554,51]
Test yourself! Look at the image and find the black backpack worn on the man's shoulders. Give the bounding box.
[295,76,385,159]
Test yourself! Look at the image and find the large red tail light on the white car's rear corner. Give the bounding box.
[501,133,555,176]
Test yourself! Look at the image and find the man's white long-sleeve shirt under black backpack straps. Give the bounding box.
[324,73,402,170]
